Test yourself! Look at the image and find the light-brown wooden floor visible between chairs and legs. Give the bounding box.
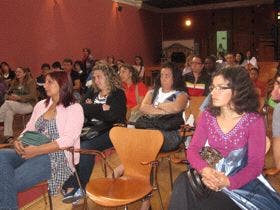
[4,115,280,210]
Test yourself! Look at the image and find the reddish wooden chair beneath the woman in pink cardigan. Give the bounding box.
[0,143,53,210]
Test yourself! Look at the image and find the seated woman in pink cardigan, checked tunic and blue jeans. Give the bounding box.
[0,71,84,209]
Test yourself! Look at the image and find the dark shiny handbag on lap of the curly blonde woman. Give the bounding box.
[80,118,113,141]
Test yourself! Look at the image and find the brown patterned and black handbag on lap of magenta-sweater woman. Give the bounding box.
[186,146,223,198]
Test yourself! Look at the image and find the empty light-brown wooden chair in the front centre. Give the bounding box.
[86,127,163,209]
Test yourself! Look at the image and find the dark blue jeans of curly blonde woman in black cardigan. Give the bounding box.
[63,131,113,189]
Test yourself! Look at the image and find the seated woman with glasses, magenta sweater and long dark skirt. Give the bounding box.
[169,67,280,210]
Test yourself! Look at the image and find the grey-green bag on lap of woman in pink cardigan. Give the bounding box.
[20,131,51,146]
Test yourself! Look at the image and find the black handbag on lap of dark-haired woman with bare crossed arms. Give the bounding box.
[135,112,184,131]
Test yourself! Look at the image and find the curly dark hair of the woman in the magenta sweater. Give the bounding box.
[209,66,260,116]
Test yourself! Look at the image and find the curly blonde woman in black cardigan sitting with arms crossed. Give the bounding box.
[63,64,126,203]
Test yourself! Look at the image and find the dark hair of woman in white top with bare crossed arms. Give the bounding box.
[155,62,186,92]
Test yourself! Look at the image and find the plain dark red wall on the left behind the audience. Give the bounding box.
[0,0,161,75]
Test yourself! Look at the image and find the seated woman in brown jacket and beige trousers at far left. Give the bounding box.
[0,67,37,143]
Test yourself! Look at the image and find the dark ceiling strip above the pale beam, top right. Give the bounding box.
[142,0,243,9]
